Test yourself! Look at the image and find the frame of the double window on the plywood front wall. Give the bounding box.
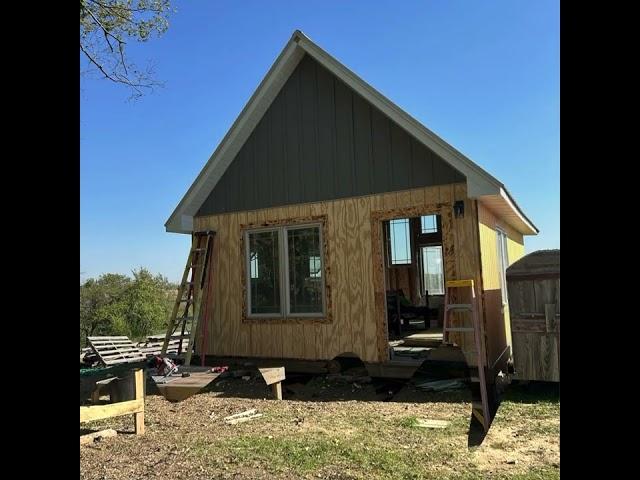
[242,221,329,320]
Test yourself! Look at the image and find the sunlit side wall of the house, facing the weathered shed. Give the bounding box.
[478,202,524,370]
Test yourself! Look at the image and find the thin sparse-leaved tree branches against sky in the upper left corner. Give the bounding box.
[80,0,171,98]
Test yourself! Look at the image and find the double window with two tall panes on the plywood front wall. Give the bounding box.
[245,225,324,318]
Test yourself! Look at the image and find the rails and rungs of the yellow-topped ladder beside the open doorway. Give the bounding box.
[442,280,491,432]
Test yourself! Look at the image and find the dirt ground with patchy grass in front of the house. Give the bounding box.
[80,376,560,480]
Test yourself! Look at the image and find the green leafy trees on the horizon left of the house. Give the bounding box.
[80,268,177,346]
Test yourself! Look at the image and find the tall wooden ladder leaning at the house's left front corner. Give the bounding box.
[160,231,215,365]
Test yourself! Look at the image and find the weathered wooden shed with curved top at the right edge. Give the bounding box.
[507,250,560,382]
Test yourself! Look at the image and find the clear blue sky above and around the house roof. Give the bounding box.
[80,0,560,281]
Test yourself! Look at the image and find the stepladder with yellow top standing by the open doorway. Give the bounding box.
[442,279,491,432]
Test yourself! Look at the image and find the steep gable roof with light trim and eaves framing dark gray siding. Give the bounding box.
[165,30,538,235]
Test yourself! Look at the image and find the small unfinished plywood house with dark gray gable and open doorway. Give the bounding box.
[165,31,538,382]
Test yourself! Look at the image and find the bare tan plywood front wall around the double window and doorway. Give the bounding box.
[195,184,480,362]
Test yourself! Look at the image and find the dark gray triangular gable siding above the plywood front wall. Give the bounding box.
[197,55,465,216]
